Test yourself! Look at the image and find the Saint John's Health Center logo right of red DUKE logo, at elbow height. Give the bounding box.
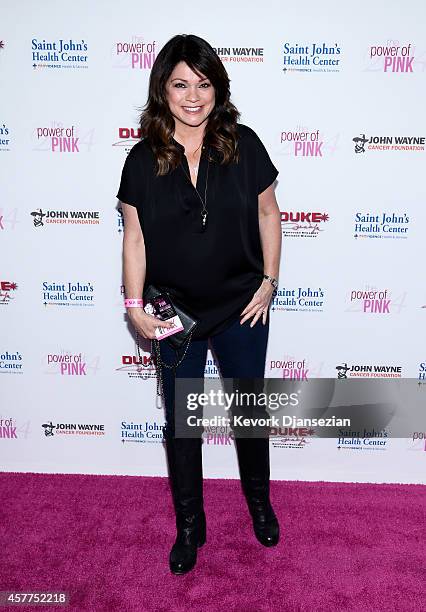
[354,212,410,239]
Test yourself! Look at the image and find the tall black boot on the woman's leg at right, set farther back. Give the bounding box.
[235,437,279,546]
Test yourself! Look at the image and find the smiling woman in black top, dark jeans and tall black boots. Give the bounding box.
[117,35,281,574]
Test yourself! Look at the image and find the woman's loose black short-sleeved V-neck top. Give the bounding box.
[117,124,278,338]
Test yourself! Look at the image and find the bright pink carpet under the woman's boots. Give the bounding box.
[0,473,426,612]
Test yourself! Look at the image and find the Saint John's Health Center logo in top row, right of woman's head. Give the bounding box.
[283,42,342,73]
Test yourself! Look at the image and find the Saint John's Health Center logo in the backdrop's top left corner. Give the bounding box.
[31,38,88,70]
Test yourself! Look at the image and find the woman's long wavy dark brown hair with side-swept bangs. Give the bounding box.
[140,34,240,175]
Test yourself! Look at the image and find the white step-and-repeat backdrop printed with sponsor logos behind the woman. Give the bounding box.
[0,0,426,482]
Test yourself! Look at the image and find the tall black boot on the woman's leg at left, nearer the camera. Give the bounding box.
[164,430,206,574]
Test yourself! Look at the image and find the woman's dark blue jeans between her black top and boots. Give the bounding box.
[156,313,269,433]
